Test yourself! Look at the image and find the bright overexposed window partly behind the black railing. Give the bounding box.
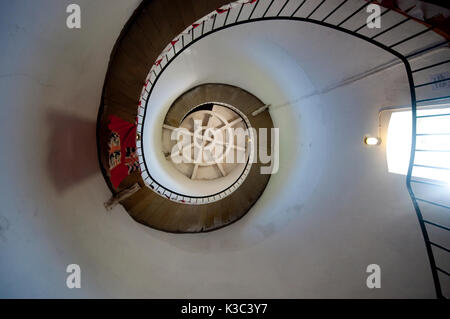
[386,105,450,184]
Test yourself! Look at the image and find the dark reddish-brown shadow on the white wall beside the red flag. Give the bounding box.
[47,110,100,193]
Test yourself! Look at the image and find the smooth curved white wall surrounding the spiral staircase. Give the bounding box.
[0,0,434,298]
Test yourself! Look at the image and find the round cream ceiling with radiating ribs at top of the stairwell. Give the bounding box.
[162,102,252,182]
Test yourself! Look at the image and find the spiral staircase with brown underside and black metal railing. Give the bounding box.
[97,0,450,298]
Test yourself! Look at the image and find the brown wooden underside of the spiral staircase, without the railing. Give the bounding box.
[97,0,273,232]
